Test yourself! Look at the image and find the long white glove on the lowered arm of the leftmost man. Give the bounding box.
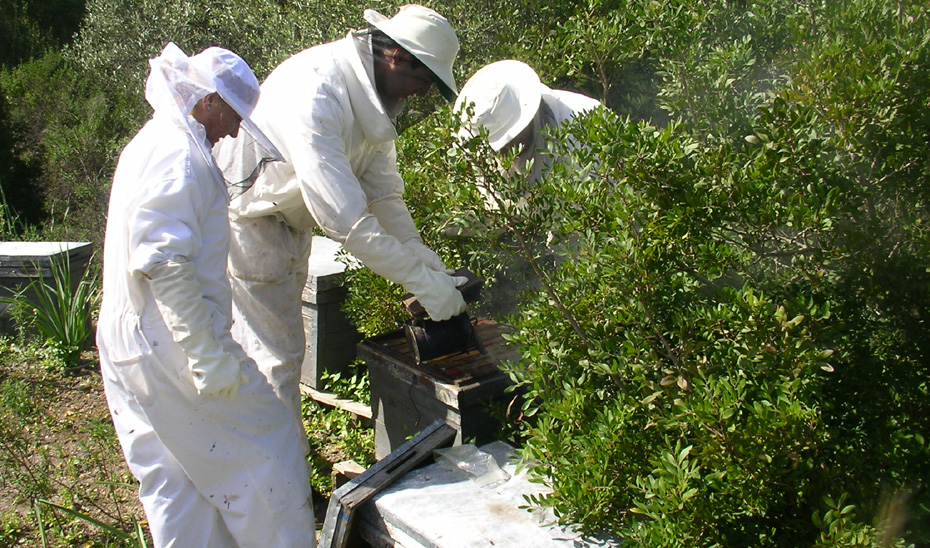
[148,261,248,398]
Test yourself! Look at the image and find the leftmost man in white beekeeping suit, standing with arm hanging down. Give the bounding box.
[97,44,315,548]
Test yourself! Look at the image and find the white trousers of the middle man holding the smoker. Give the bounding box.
[229,216,313,455]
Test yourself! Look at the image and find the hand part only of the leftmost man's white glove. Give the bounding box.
[178,327,248,399]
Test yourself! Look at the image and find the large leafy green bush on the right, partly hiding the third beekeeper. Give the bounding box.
[358,0,930,546]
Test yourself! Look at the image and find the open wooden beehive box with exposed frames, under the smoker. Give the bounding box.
[358,319,520,459]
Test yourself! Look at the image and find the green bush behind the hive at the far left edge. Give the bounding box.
[0,53,131,249]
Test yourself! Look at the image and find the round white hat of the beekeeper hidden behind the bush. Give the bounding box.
[454,59,544,152]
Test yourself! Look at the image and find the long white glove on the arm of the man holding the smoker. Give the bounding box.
[343,214,468,321]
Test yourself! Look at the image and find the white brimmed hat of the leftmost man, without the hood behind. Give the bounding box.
[191,47,284,162]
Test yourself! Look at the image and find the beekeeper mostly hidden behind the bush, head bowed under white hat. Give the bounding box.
[453,59,600,188]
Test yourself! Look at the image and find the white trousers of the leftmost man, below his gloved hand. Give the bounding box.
[98,307,316,548]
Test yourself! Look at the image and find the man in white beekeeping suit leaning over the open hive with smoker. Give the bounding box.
[215,5,466,450]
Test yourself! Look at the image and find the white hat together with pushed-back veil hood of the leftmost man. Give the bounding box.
[145,42,283,161]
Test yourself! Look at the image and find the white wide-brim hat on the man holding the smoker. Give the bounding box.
[364,4,459,101]
